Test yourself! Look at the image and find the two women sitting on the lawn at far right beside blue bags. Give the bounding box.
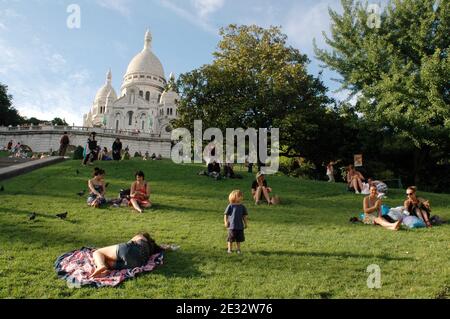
[362,185,432,230]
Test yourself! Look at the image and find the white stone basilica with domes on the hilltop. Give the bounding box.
[83,31,179,136]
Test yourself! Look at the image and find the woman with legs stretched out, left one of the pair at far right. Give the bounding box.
[362,185,402,230]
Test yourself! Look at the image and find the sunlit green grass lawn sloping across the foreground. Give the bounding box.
[0,160,450,298]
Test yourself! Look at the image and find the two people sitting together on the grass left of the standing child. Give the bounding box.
[87,167,152,213]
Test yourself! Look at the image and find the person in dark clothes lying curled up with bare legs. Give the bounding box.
[90,233,165,278]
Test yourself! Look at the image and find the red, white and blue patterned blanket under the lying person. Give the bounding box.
[54,247,164,288]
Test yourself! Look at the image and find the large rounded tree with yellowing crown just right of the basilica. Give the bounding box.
[174,25,335,170]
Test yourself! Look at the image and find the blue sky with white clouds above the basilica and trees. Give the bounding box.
[0,0,362,125]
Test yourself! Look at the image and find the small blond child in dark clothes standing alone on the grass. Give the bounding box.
[223,190,248,254]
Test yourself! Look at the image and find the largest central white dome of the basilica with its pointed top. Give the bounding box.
[125,31,165,79]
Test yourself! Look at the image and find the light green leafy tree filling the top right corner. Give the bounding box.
[315,0,450,183]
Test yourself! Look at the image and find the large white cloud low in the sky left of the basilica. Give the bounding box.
[0,37,95,125]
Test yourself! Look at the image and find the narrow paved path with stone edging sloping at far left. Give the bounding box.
[0,156,64,181]
